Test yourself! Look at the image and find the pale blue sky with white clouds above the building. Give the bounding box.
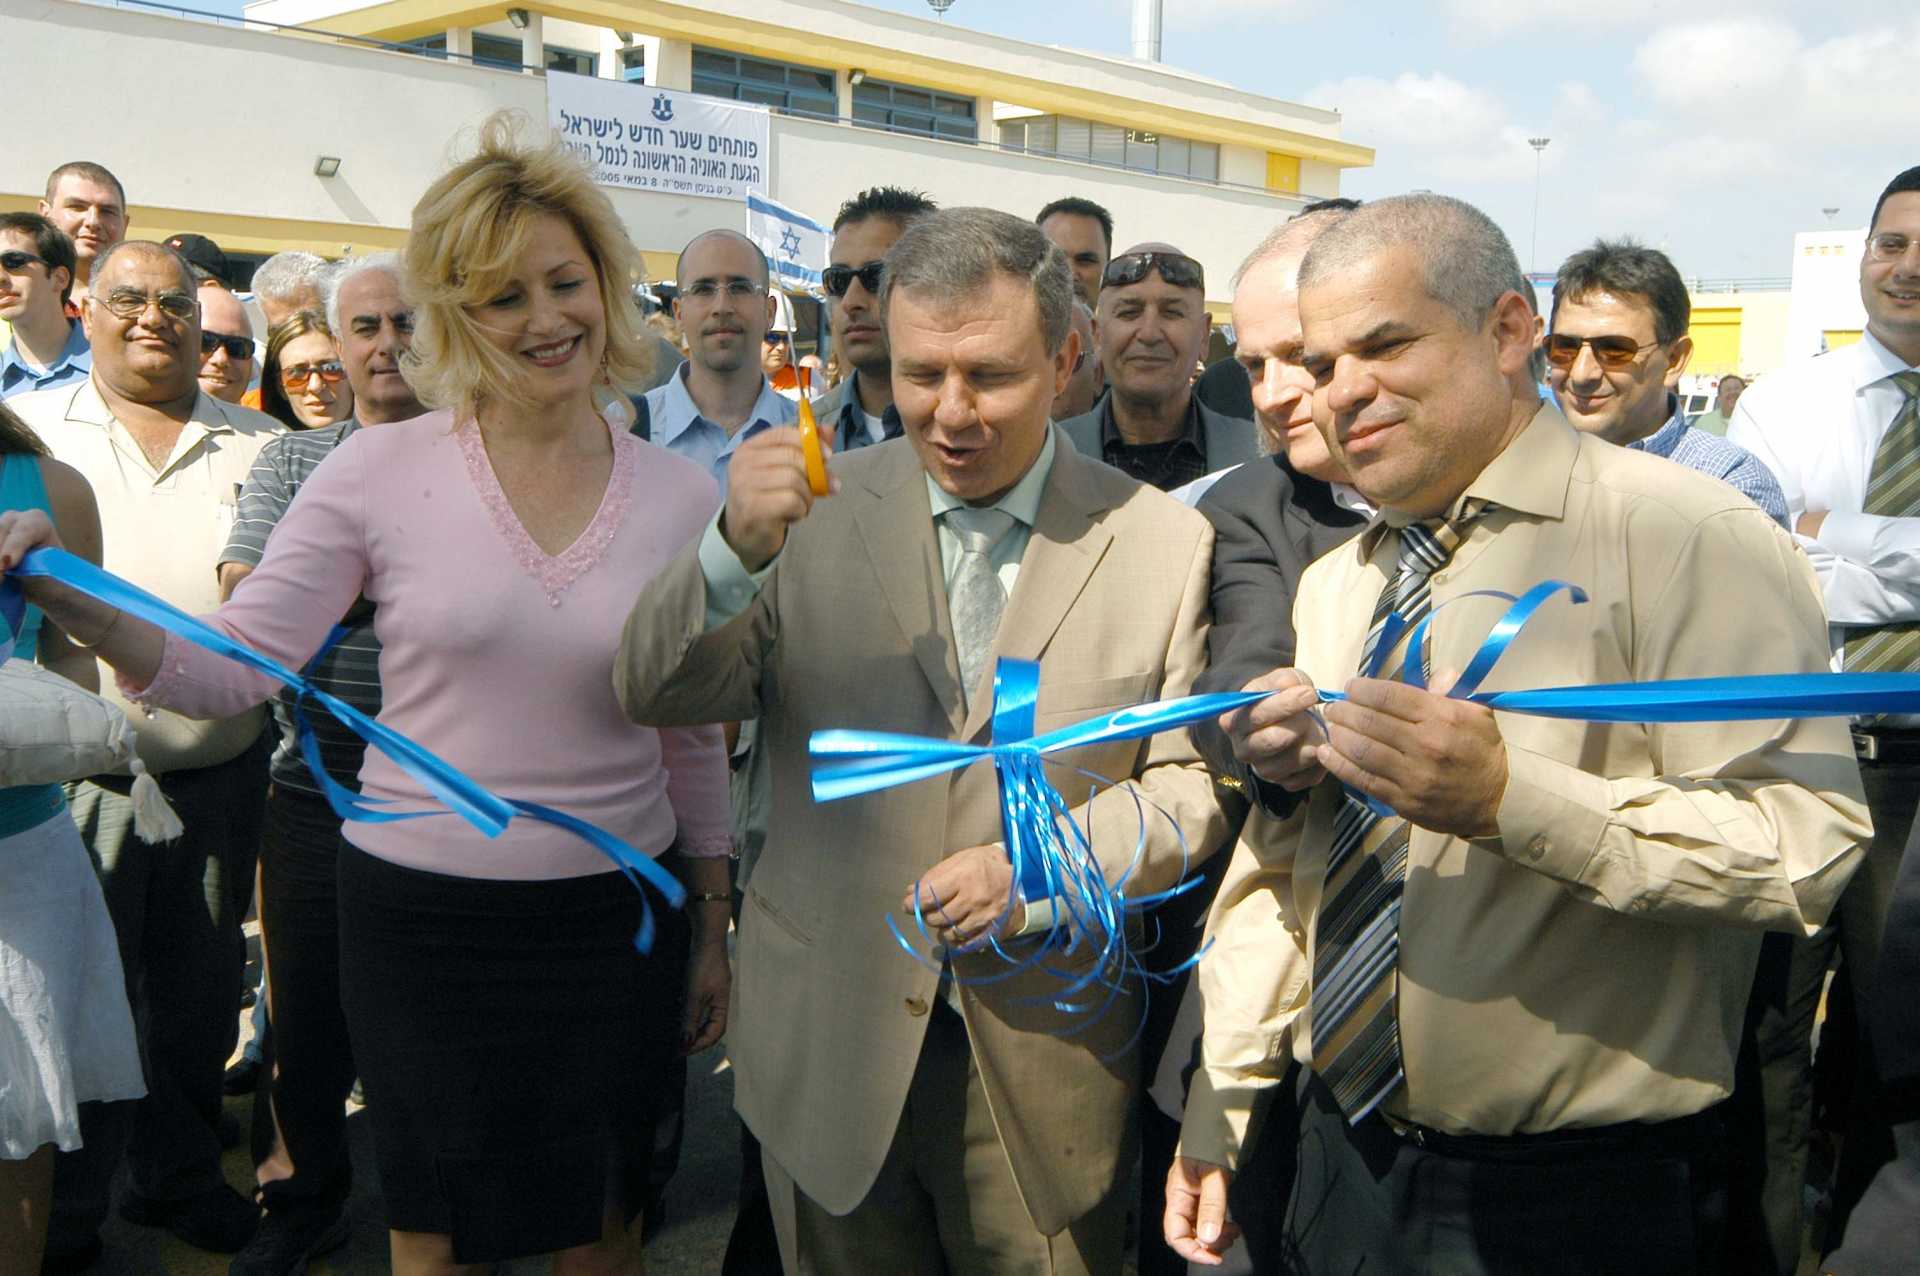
[202,0,1920,280]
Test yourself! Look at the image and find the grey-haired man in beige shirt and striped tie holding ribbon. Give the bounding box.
[1167,196,1870,1272]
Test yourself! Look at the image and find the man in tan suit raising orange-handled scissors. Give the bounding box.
[614,209,1223,1276]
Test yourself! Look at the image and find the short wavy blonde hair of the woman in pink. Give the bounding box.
[401,111,653,420]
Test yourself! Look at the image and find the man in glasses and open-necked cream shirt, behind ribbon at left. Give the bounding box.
[12,242,278,1257]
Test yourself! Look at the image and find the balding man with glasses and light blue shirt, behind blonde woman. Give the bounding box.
[645,230,799,491]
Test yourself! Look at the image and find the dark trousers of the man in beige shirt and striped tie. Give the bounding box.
[1281,1073,1726,1276]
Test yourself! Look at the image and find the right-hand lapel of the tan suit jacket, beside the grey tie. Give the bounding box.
[967,437,1114,741]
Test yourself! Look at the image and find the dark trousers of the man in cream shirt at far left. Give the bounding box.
[48,743,267,1253]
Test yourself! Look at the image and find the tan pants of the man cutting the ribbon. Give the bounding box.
[762,1007,1125,1276]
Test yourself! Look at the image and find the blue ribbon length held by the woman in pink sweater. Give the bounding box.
[0,549,687,952]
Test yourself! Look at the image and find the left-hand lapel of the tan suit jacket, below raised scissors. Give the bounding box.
[856,445,964,731]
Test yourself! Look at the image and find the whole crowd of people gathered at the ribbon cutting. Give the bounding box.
[0,115,1920,1276]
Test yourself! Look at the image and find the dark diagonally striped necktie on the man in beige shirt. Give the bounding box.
[1311,505,1490,1122]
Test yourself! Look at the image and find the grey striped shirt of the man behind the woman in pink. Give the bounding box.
[221,416,380,796]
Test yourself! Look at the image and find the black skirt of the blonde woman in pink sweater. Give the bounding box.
[340,842,687,1263]
